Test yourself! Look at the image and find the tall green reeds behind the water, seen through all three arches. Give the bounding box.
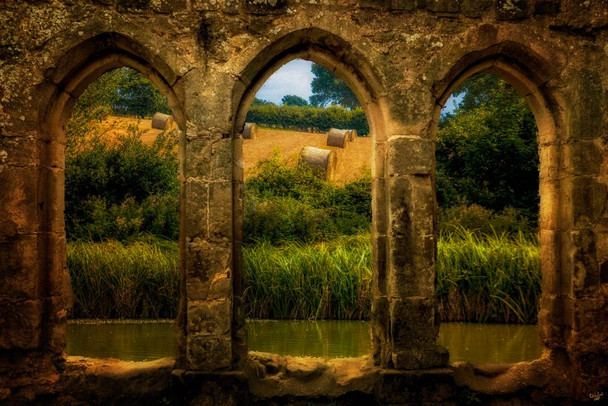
[68,230,540,323]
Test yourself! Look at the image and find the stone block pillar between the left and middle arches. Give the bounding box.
[180,71,233,372]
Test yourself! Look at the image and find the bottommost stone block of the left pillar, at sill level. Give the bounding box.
[186,334,232,371]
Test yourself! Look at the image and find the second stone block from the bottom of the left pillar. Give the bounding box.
[187,298,232,336]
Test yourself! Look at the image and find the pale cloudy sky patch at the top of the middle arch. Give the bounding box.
[255,59,313,104]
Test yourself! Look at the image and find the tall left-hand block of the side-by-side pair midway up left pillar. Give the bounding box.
[180,178,209,240]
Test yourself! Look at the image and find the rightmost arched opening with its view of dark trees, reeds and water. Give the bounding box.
[435,73,542,364]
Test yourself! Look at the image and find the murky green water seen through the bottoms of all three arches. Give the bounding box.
[66,320,542,364]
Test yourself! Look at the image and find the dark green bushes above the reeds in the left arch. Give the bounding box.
[65,128,179,241]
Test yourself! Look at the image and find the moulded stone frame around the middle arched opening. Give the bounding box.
[228,30,386,360]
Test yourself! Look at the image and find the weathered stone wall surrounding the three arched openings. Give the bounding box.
[0,0,608,404]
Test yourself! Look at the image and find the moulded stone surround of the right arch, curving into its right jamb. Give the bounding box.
[430,41,569,355]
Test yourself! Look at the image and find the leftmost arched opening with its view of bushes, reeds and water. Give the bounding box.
[64,67,180,361]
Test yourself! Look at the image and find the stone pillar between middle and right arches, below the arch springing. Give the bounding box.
[387,134,447,369]
